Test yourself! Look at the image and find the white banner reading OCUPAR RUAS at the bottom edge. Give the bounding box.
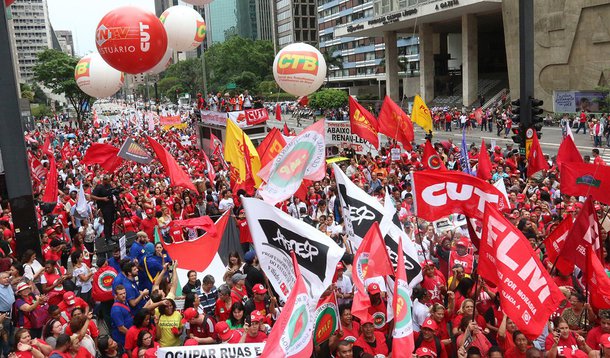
[157,343,265,358]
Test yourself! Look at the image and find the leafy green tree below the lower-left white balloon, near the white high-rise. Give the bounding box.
[34,49,93,128]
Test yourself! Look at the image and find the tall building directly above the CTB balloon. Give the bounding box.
[275,0,316,48]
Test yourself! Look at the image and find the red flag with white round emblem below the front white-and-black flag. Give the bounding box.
[260,251,315,358]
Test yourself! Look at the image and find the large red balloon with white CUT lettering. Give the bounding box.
[95,6,167,74]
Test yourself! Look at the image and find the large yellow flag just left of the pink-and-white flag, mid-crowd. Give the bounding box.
[225,118,261,188]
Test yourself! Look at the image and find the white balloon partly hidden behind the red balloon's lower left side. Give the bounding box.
[74,52,125,98]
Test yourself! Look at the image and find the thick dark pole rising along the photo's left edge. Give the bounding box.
[0,1,41,257]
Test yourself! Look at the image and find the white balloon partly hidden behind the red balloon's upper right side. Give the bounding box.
[160,5,206,51]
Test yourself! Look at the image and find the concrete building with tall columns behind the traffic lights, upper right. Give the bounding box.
[333,0,610,110]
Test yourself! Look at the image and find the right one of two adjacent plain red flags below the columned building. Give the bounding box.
[377,96,414,150]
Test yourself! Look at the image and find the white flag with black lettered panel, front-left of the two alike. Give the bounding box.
[242,198,345,301]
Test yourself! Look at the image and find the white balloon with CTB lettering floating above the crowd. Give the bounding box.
[273,43,326,96]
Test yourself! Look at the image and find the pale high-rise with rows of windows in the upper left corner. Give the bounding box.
[9,0,53,82]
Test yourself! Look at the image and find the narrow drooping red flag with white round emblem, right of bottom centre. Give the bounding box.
[392,236,415,357]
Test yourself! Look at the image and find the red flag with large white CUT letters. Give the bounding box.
[413,170,509,221]
